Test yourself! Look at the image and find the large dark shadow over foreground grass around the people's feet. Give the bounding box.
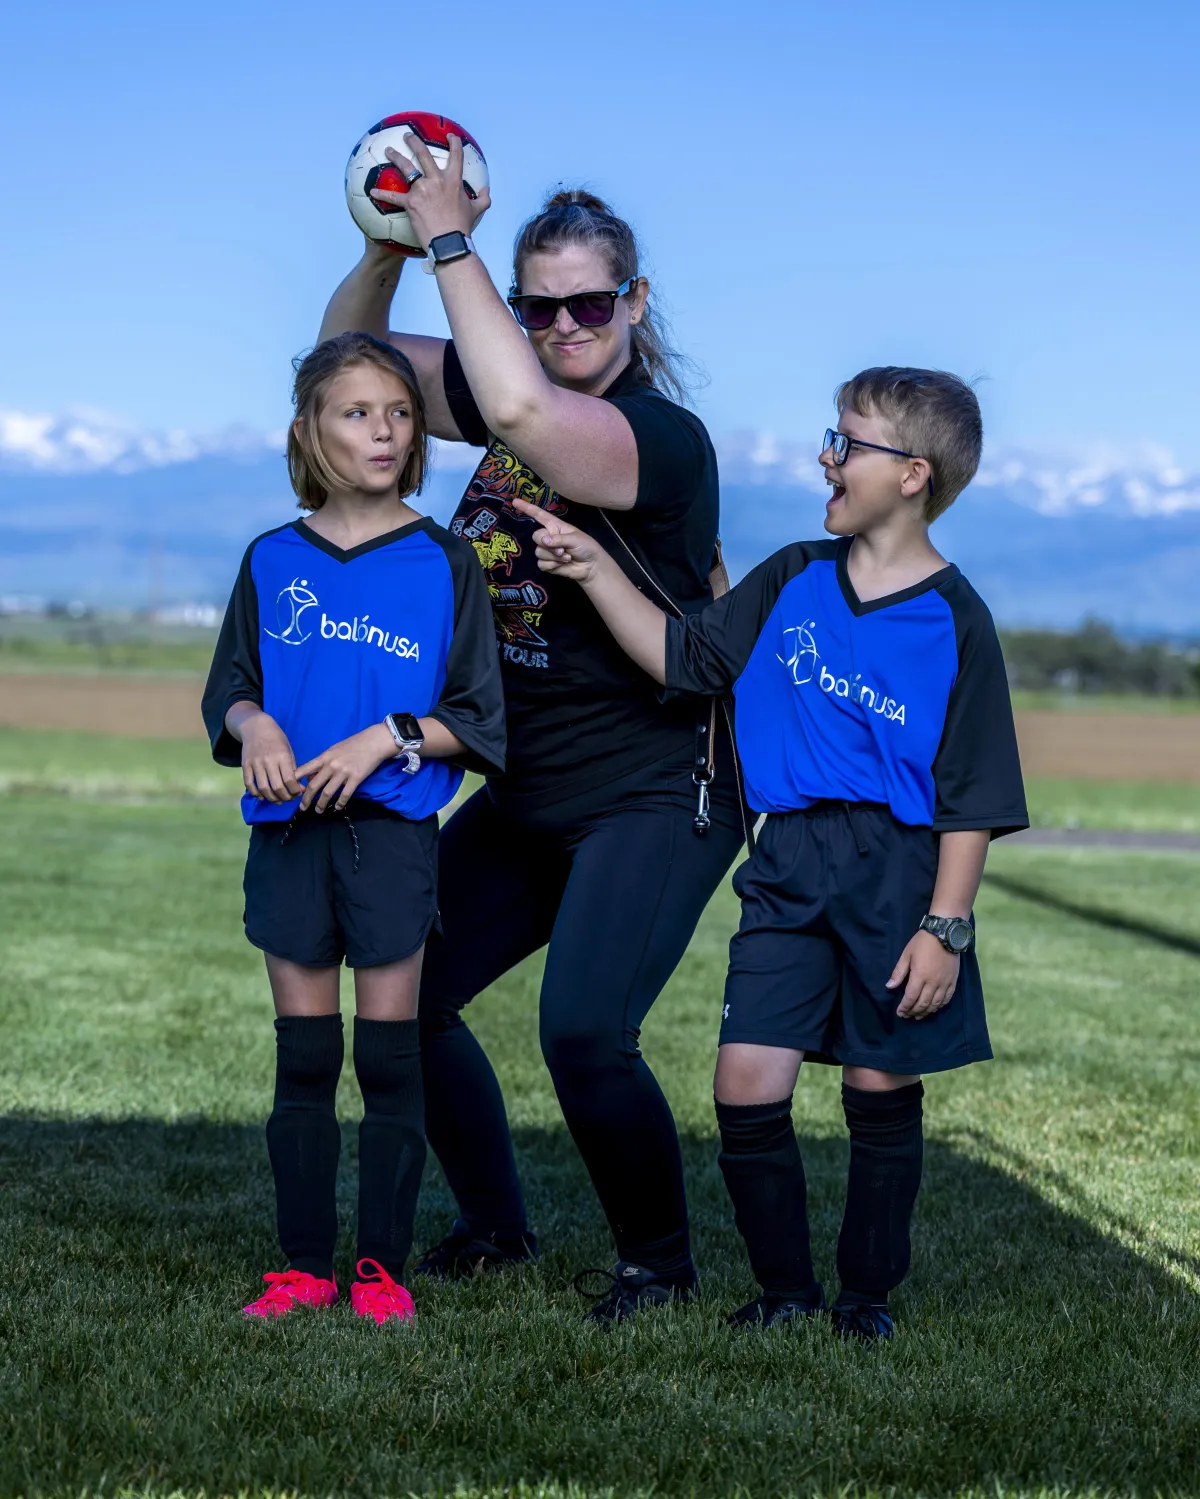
[0,1118,1200,1496]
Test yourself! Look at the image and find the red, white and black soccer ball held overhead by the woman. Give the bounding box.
[346,111,487,256]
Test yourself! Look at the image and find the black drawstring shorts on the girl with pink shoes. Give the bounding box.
[243,797,437,968]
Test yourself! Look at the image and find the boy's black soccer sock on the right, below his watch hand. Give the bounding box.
[837,1082,924,1303]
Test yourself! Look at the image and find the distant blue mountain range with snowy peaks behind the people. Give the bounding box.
[0,412,1200,637]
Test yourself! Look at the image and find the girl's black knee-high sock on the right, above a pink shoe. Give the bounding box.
[354,1016,425,1280]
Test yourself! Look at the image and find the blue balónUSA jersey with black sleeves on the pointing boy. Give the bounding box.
[667,540,1028,832]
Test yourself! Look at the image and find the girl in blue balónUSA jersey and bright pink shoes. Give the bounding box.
[204,333,505,1324]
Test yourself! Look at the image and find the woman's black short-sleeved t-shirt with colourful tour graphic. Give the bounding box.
[443,343,719,802]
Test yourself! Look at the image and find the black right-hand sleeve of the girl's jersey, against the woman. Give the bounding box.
[428,528,505,775]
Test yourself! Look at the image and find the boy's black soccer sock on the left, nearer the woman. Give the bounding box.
[716,1097,819,1301]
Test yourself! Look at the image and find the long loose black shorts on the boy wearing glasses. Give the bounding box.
[721,802,992,1073]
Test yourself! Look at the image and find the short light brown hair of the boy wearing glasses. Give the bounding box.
[833,364,983,522]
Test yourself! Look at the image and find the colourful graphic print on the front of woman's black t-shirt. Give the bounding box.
[449,439,566,670]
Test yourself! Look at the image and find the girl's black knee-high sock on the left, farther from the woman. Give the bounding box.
[267,1015,345,1279]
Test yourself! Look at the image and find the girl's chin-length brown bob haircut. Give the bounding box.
[288,333,428,510]
